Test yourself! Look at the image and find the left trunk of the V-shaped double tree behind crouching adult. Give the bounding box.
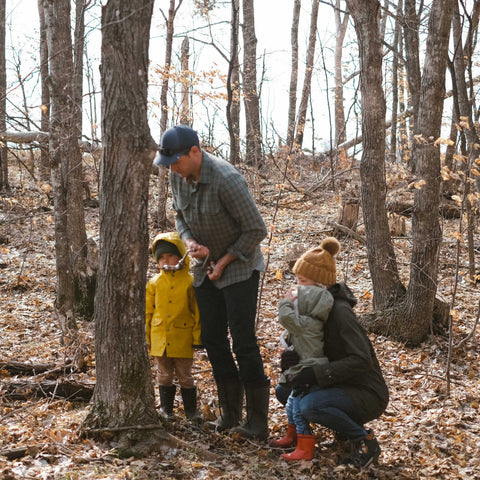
[347,0,404,309]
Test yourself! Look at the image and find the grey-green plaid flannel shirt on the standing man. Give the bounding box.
[170,152,267,288]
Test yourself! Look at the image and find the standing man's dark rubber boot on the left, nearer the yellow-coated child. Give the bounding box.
[206,378,243,432]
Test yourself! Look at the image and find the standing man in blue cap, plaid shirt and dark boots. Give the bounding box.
[154,125,270,440]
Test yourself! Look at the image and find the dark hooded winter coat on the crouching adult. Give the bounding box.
[314,283,389,424]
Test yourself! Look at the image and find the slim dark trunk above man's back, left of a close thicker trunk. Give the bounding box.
[227,0,240,165]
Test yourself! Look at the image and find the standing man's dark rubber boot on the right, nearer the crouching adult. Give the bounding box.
[232,377,270,440]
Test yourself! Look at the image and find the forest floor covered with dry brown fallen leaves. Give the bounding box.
[0,156,480,480]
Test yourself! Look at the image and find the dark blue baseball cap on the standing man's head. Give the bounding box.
[153,125,200,167]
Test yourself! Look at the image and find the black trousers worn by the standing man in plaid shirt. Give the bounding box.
[195,271,265,383]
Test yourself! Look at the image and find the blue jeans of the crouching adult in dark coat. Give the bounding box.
[275,385,368,440]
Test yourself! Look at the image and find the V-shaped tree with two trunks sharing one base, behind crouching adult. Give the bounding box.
[347,0,452,345]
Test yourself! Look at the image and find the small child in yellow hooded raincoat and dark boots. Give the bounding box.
[146,232,201,421]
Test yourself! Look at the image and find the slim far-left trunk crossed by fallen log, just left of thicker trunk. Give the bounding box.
[38,0,51,182]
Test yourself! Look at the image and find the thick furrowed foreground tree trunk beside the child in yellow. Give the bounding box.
[83,0,158,442]
